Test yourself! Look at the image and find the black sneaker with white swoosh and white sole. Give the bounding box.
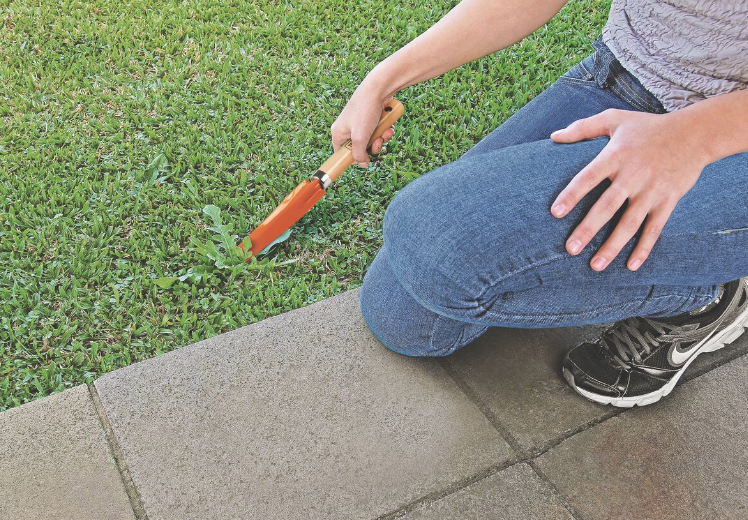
[563,279,748,408]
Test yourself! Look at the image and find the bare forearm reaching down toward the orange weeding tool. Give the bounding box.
[364,0,568,94]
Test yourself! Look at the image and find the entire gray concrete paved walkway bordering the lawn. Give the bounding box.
[0,291,748,520]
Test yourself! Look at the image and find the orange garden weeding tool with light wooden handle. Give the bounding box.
[239,99,403,255]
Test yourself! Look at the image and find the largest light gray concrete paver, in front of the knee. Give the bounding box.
[95,290,514,520]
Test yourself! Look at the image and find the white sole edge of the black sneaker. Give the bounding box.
[562,298,748,408]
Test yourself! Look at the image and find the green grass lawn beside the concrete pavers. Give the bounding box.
[0,0,609,410]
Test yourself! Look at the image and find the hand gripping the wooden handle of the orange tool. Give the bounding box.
[330,80,395,168]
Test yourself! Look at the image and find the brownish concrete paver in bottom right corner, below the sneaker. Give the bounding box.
[537,357,748,520]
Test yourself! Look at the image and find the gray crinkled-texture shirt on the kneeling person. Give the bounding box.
[603,0,748,111]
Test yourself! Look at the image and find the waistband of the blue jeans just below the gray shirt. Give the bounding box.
[592,36,667,114]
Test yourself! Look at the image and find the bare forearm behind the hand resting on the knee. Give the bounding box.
[669,90,748,163]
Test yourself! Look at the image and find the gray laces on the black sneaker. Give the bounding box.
[601,317,682,368]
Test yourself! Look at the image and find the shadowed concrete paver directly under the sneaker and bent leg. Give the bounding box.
[447,326,748,451]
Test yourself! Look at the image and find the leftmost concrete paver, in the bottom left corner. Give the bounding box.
[0,386,135,520]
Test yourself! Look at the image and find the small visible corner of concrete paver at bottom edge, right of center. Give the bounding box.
[404,464,573,520]
